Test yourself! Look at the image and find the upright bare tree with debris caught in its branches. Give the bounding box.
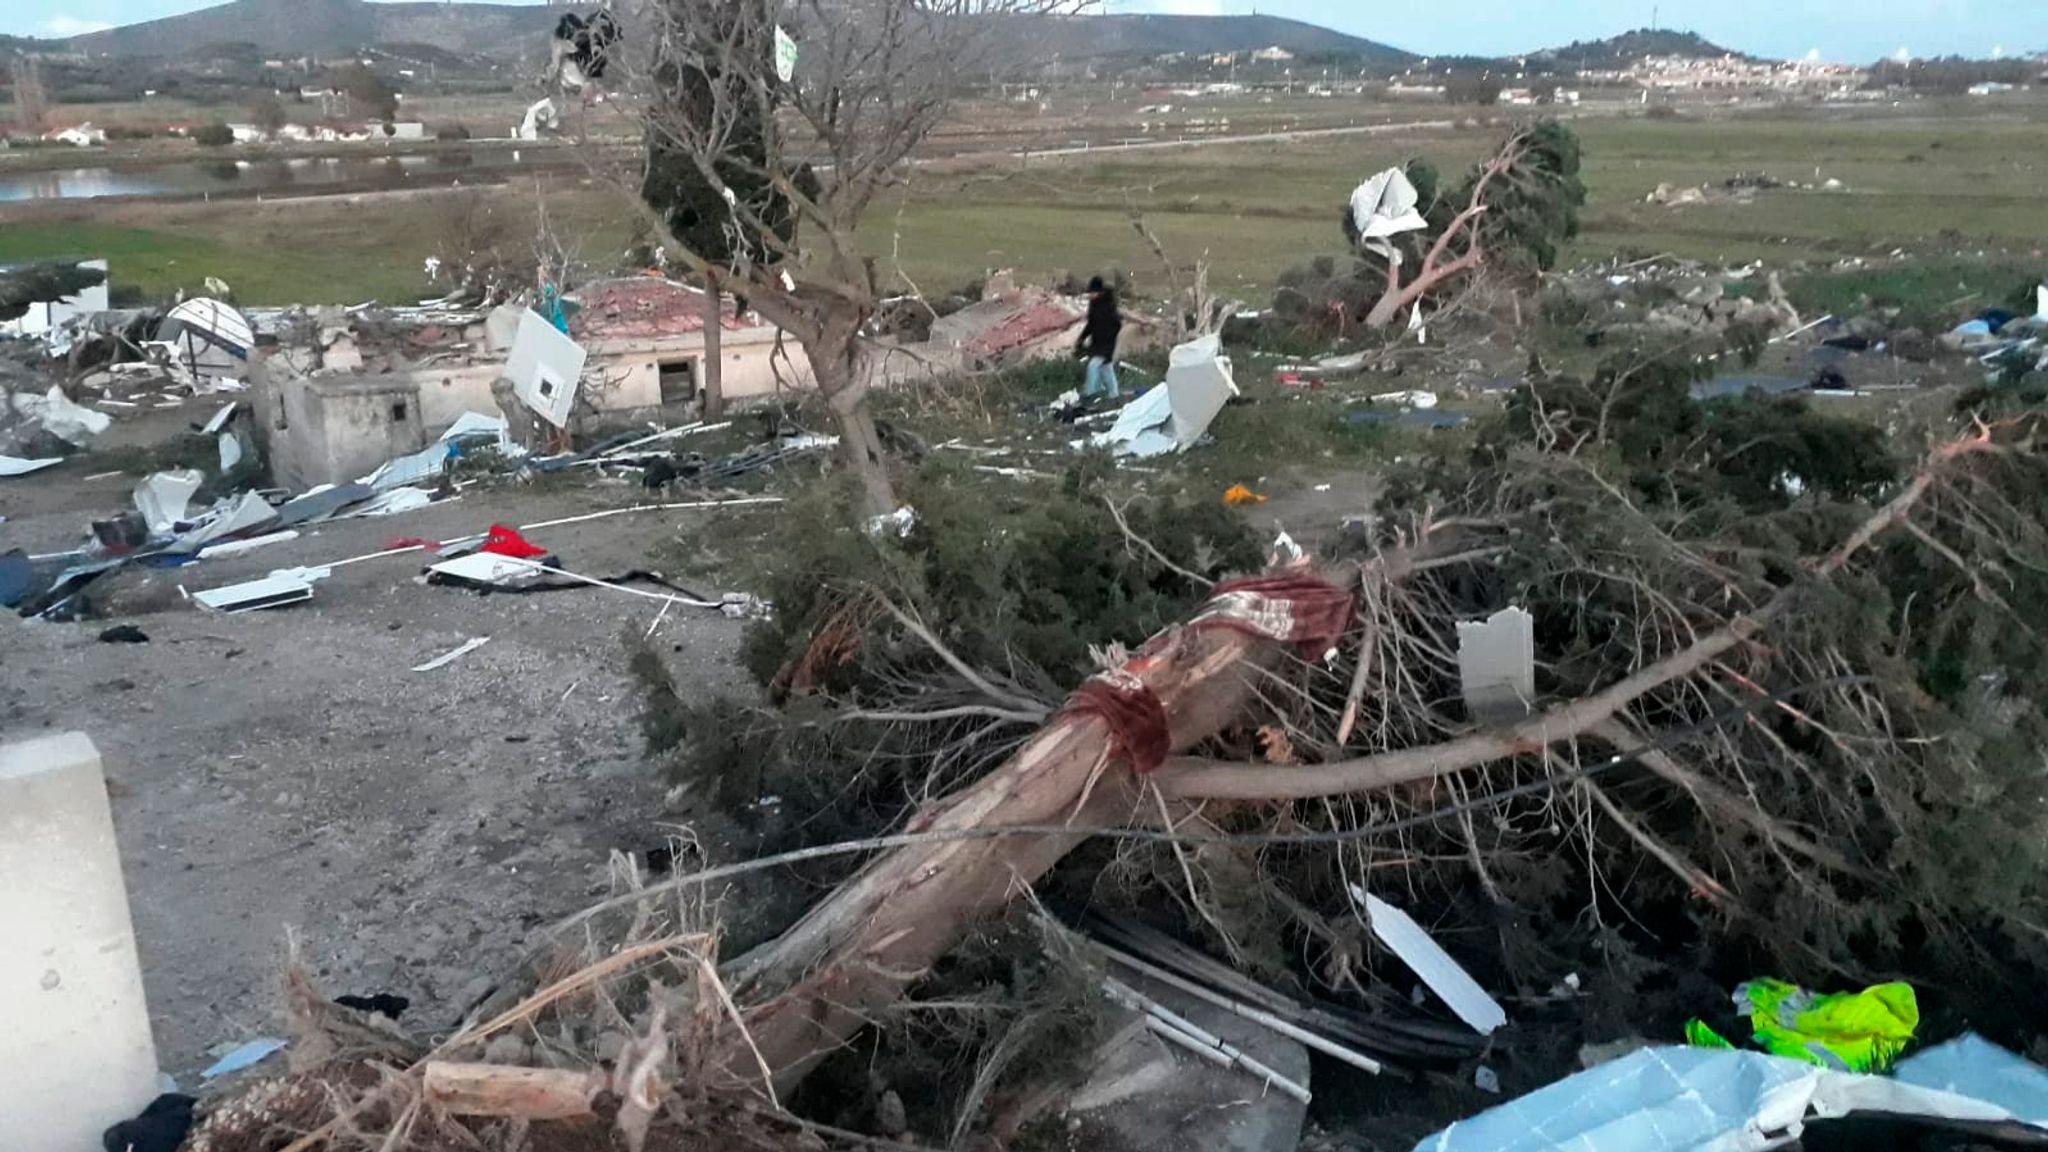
[625,0,1094,515]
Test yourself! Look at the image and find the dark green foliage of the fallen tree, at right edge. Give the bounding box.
[1382,344,2048,998]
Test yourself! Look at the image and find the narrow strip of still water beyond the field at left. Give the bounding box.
[0,148,545,203]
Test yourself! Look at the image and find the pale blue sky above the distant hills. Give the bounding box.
[0,0,2048,64]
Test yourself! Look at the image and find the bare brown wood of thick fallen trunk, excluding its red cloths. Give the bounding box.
[721,610,1282,1088]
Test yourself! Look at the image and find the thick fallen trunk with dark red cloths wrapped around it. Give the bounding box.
[719,572,1352,1088]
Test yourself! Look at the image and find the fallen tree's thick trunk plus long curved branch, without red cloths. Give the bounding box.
[721,424,1993,1091]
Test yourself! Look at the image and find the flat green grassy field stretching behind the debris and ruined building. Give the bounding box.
[0,107,2048,303]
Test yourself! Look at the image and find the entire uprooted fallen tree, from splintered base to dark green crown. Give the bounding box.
[203,373,2048,1146]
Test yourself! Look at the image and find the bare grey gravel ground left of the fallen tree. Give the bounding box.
[0,453,772,1086]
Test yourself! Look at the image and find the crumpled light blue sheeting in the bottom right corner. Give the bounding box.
[1415,1041,2042,1152]
